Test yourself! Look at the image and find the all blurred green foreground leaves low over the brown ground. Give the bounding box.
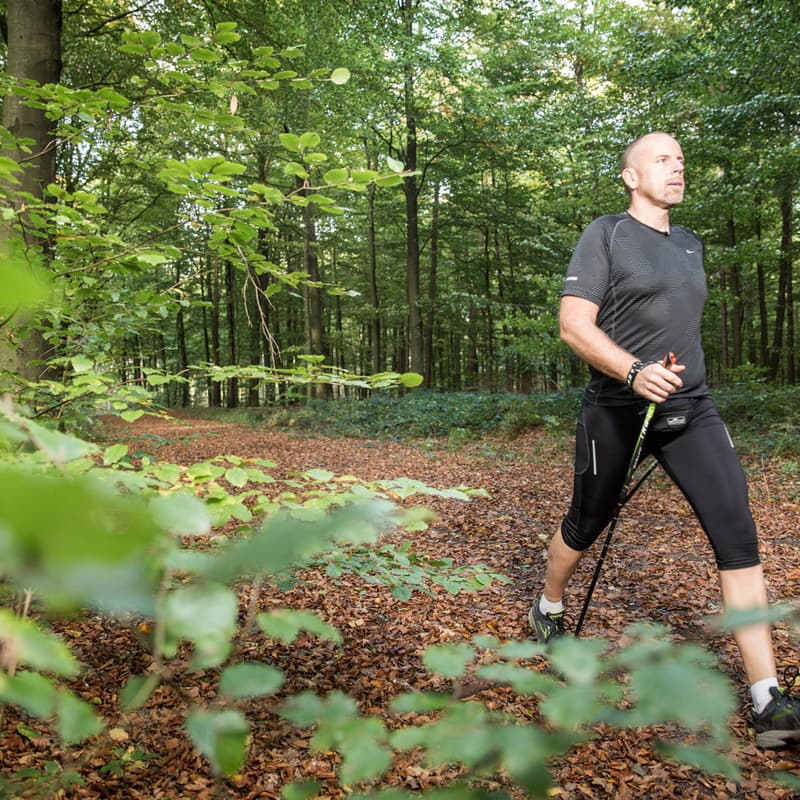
[0,396,791,797]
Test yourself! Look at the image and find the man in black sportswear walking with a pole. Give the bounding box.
[528,132,800,747]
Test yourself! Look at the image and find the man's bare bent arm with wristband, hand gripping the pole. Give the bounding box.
[559,295,686,403]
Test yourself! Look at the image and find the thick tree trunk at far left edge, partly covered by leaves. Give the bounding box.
[0,0,62,380]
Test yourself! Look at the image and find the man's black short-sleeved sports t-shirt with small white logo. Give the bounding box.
[562,212,708,405]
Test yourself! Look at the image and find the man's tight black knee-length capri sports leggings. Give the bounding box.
[561,397,760,570]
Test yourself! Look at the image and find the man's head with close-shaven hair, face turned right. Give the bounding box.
[622,133,684,208]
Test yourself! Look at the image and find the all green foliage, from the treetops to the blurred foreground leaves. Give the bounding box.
[0,0,798,797]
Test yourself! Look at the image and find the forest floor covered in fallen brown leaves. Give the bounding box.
[0,412,800,800]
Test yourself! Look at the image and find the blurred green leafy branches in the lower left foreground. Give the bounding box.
[0,396,502,777]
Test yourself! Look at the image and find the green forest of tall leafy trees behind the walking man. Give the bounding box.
[0,0,800,407]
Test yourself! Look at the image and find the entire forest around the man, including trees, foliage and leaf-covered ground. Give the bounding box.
[0,0,800,800]
